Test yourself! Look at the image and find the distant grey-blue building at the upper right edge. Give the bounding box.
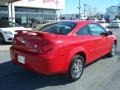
[105,6,120,20]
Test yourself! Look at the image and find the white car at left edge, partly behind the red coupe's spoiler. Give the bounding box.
[0,21,31,43]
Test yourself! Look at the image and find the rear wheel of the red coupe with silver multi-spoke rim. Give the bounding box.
[67,55,84,81]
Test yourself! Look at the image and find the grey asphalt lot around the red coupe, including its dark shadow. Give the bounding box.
[0,30,120,90]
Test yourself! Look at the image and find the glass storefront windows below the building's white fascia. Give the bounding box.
[0,6,56,27]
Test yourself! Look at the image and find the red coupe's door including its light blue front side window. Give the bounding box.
[89,24,109,59]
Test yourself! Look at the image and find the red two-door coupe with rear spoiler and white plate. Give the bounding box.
[10,21,117,80]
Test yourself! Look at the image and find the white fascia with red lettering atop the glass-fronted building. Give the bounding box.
[14,0,65,9]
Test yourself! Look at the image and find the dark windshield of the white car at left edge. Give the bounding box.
[0,21,21,28]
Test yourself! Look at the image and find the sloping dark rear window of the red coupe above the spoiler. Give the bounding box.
[38,22,76,35]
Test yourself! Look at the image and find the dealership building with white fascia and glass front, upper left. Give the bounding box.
[0,0,64,27]
